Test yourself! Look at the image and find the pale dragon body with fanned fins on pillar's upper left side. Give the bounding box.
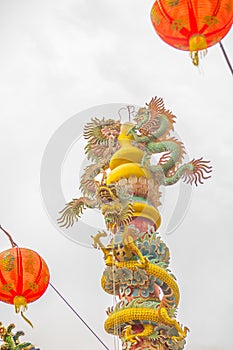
[58,118,123,227]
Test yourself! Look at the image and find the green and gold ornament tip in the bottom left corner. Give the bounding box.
[0,322,40,350]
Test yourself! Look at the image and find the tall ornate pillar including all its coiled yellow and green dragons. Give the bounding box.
[58,97,212,350]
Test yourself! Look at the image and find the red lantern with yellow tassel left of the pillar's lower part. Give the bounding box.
[0,247,49,324]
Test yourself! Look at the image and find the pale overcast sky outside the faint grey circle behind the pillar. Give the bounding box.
[0,0,233,350]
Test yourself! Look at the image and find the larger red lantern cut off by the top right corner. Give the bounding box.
[151,0,233,65]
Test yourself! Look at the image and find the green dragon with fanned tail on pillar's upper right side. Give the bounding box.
[128,97,212,186]
